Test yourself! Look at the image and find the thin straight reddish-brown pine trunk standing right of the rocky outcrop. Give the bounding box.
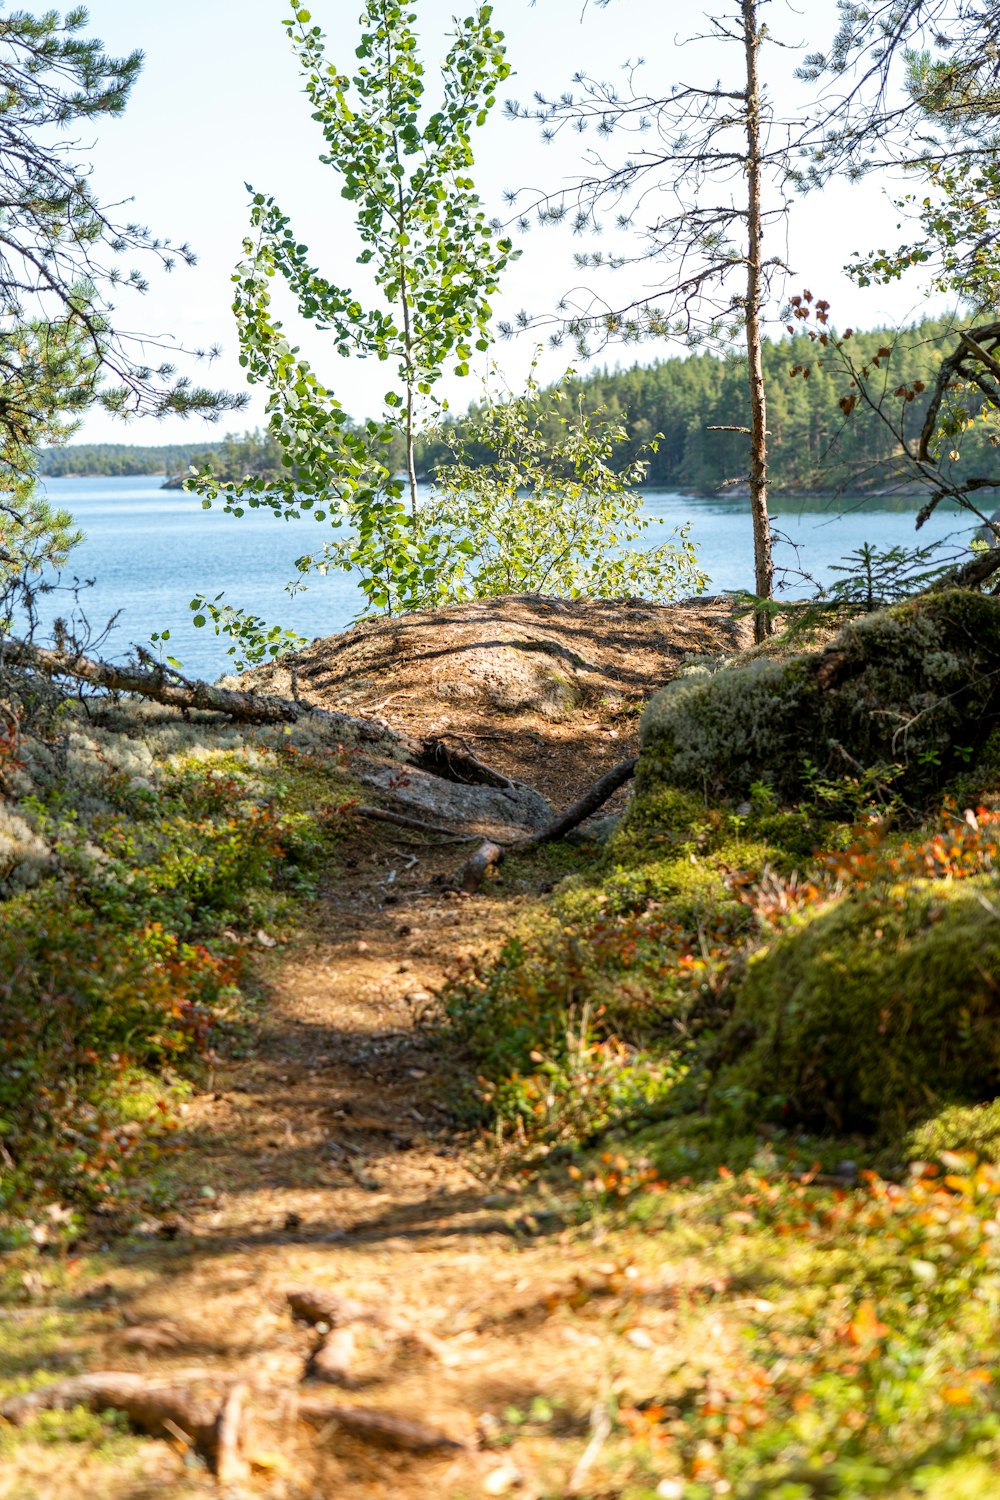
[742,0,774,641]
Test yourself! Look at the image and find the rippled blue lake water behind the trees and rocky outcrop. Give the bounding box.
[27,477,973,680]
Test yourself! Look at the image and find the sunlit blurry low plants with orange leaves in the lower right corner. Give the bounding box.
[554,1146,1000,1500]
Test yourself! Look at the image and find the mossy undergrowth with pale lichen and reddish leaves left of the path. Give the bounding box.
[0,704,352,1241]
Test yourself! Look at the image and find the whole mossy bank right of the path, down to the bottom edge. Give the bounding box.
[445,596,1000,1500]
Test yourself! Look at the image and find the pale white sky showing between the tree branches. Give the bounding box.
[76,0,941,444]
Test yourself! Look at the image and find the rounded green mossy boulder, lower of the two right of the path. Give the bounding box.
[712,876,1000,1139]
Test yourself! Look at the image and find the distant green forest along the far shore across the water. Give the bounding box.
[42,321,997,494]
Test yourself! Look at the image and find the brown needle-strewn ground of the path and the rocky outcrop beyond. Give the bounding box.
[0,602,767,1500]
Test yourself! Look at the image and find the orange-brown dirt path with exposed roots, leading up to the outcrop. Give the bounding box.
[0,842,695,1500]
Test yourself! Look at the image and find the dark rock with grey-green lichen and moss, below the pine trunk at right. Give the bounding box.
[639,590,1000,803]
